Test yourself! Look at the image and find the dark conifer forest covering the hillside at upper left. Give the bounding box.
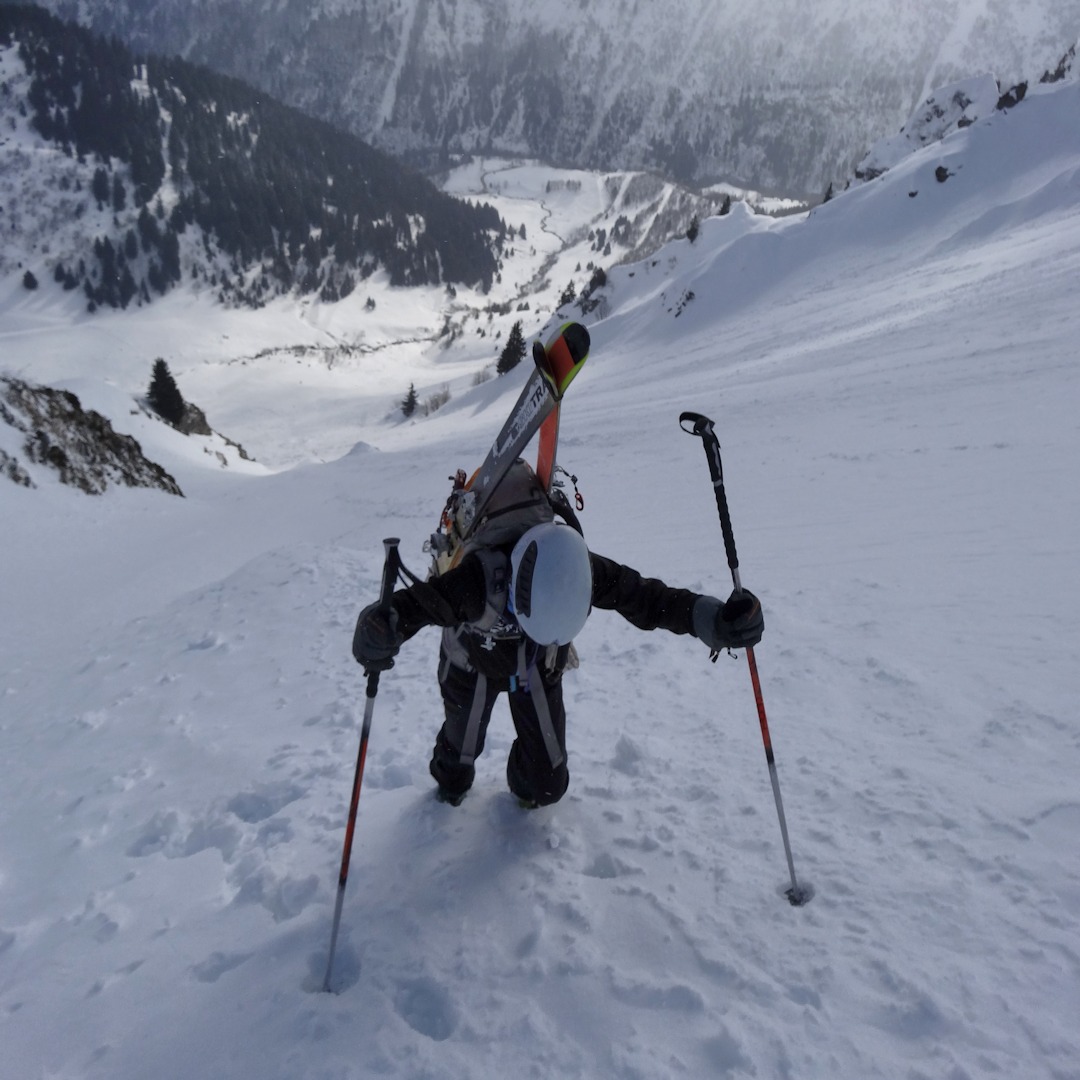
[0,6,508,307]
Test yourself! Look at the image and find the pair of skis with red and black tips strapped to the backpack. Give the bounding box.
[428,323,590,572]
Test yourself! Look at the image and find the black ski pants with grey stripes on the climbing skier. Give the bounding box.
[431,657,570,806]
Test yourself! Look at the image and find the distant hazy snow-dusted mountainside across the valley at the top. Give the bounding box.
[27,0,1080,194]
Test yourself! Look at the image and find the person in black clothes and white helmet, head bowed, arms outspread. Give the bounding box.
[352,462,765,808]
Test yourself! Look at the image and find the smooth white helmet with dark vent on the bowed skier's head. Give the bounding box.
[510,522,593,645]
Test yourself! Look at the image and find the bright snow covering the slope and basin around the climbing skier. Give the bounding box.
[0,76,1080,1080]
